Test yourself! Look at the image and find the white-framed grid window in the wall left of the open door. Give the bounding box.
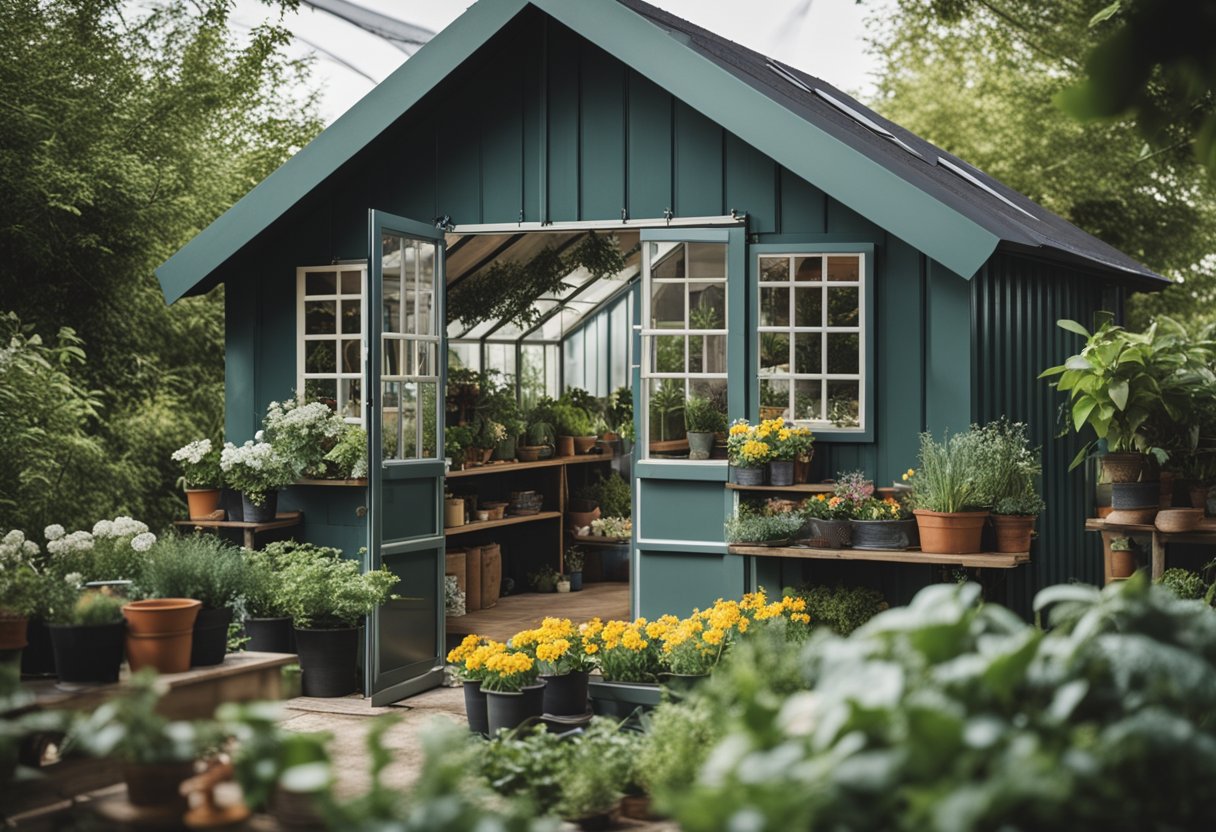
[295,264,367,425]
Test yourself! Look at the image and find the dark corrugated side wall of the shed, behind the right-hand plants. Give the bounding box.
[972,254,1105,615]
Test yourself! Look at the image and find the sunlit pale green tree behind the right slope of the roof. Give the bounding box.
[872,0,1216,327]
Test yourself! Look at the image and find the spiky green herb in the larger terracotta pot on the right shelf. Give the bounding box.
[912,433,989,555]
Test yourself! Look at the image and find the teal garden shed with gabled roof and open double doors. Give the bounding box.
[157,0,1165,701]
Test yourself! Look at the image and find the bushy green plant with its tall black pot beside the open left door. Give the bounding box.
[281,546,400,697]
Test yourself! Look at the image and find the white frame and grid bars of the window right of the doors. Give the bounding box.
[754,251,872,435]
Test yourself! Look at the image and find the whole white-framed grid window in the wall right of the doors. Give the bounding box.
[756,252,869,433]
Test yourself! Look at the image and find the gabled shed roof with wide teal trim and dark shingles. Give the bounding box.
[157,0,1164,303]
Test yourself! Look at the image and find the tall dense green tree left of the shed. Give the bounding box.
[0,0,320,525]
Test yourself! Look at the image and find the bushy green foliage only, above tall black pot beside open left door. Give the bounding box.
[281,546,400,630]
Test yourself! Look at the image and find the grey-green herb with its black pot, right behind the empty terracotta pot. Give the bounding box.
[136,534,248,668]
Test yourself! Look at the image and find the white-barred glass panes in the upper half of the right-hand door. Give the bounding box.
[641,241,727,457]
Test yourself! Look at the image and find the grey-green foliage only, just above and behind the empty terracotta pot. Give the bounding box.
[134,534,248,609]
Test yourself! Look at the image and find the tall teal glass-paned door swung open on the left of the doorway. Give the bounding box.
[365,210,446,705]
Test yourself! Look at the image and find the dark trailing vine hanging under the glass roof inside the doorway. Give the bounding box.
[447,231,627,328]
